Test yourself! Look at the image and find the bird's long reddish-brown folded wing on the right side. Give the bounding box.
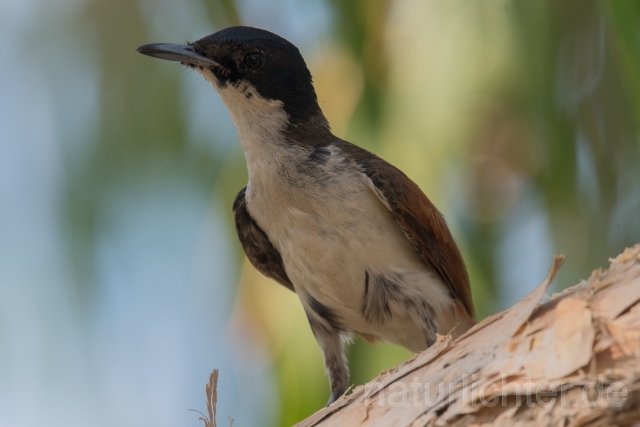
[334,138,475,320]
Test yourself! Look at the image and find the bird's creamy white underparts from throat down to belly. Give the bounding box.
[196,68,453,351]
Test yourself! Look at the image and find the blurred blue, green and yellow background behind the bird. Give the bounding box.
[0,0,640,427]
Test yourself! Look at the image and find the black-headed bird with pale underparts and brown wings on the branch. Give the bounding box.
[136,26,475,406]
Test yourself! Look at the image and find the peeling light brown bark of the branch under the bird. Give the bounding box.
[297,245,640,427]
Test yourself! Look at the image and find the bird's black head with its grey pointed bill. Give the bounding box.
[138,27,323,130]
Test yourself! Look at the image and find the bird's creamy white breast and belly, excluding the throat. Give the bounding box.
[242,142,450,348]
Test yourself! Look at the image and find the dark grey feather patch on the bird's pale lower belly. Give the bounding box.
[360,271,403,325]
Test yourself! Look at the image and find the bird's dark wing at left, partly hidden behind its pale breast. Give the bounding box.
[233,187,295,292]
